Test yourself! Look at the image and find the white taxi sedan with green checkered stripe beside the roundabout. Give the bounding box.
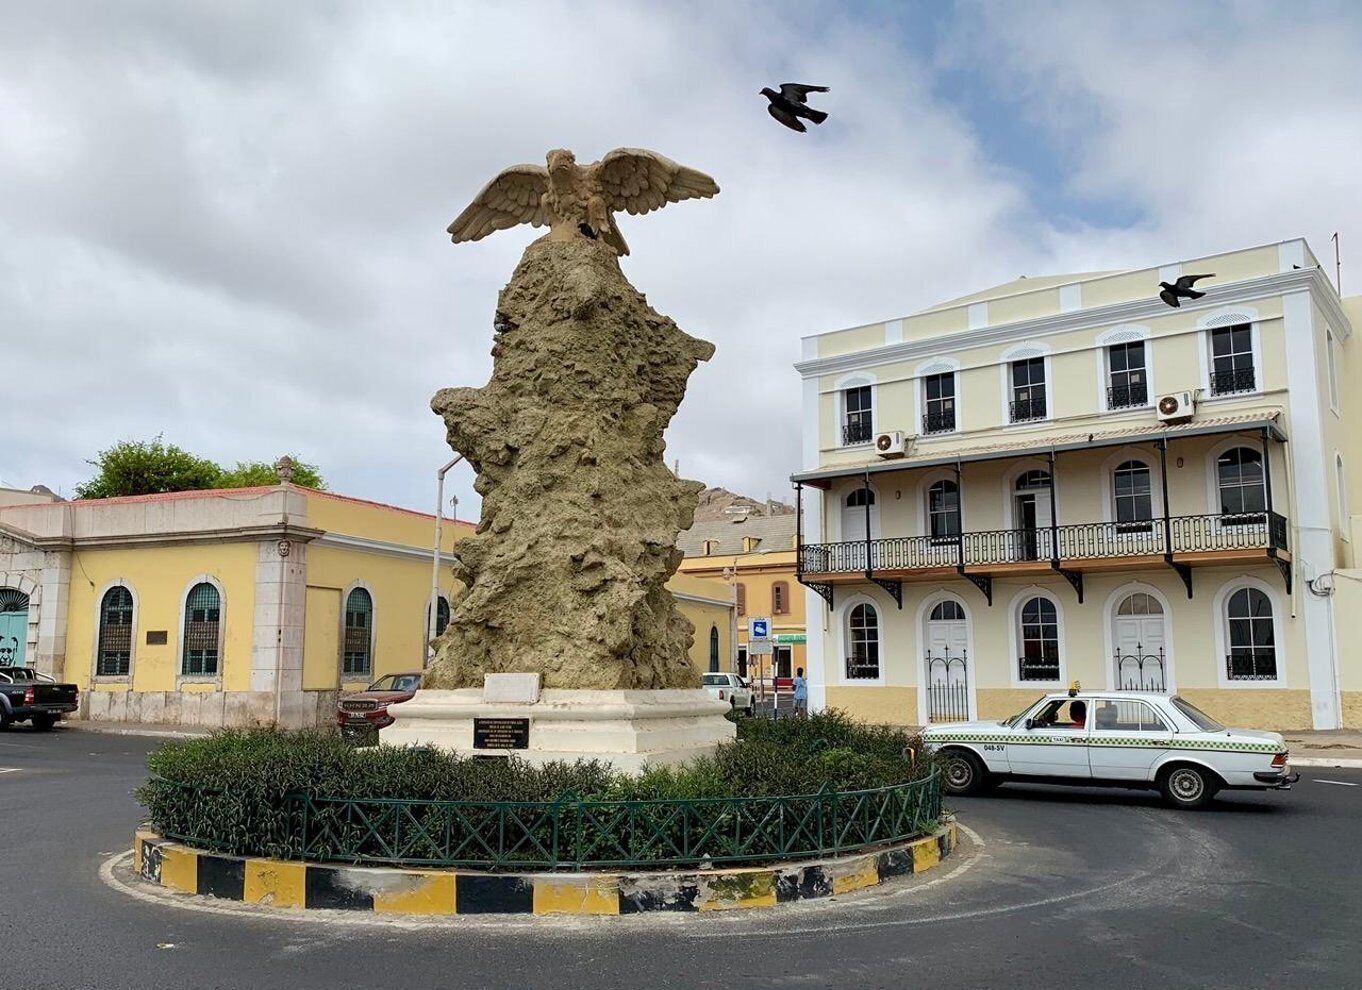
[922,688,1299,808]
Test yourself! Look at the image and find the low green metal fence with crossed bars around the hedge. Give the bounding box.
[153,771,941,870]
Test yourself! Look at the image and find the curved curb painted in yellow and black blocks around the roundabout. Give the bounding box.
[132,821,956,915]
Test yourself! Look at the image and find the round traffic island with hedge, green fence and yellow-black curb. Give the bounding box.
[133,712,955,915]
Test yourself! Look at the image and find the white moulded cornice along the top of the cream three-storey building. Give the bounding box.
[794,268,1351,379]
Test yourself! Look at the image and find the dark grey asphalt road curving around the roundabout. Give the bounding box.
[0,729,1362,990]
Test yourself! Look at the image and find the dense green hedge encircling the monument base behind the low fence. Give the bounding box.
[138,712,940,869]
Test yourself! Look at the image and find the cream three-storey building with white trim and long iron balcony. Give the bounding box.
[794,240,1362,729]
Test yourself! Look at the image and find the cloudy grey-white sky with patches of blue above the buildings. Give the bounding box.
[0,0,1362,516]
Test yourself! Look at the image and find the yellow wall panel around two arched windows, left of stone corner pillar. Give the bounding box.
[64,541,257,692]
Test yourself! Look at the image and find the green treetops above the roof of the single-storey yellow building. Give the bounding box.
[76,437,327,498]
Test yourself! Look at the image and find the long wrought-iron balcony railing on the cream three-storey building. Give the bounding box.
[798,512,1288,575]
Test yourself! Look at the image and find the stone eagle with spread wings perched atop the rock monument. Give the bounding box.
[449,148,719,255]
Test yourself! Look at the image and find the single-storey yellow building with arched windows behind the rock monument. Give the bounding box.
[0,483,733,726]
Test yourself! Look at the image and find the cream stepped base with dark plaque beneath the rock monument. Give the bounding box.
[379,689,737,773]
